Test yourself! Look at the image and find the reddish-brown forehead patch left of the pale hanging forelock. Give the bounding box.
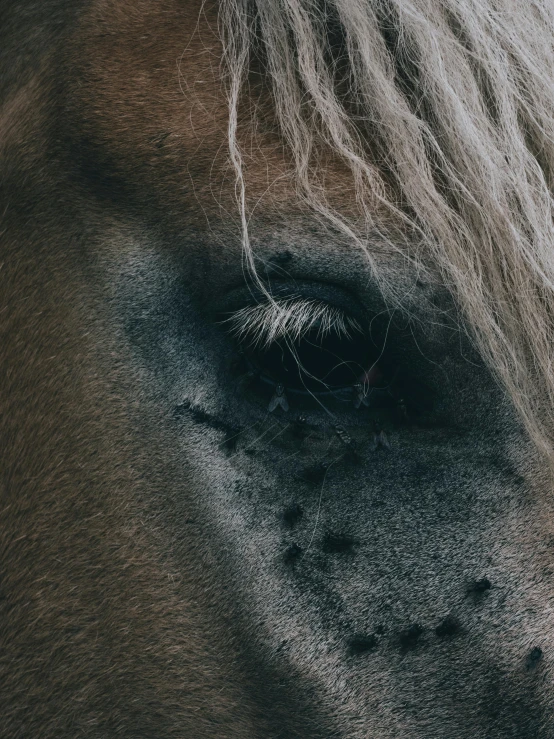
[68,0,266,209]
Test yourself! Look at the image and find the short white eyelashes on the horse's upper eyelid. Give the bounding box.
[225,297,362,349]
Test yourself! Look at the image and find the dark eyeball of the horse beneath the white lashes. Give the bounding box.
[251,328,379,393]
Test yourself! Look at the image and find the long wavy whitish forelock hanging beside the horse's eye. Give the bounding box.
[220,0,554,454]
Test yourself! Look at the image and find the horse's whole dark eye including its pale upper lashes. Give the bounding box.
[218,296,434,445]
